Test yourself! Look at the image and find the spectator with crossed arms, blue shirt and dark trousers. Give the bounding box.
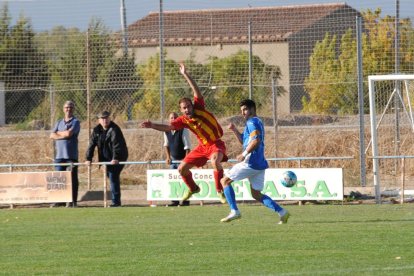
[50,101,80,207]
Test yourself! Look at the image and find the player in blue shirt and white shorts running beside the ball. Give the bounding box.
[221,99,289,224]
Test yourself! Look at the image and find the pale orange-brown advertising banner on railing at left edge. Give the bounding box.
[0,171,72,204]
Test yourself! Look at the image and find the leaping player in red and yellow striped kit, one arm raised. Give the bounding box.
[141,63,228,203]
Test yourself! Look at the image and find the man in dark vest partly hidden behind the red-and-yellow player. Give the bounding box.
[164,112,191,206]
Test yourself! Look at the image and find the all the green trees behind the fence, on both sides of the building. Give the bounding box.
[0,5,414,122]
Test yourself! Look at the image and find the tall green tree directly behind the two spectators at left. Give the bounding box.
[38,18,133,118]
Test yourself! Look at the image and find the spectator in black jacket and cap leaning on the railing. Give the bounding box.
[85,111,128,207]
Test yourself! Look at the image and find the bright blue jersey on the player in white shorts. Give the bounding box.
[242,117,269,170]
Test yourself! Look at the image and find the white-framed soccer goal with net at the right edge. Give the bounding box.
[367,75,414,203]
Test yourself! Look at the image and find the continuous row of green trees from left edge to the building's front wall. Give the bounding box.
[0,5,280,122]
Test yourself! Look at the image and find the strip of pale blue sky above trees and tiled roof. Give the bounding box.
[0,0,414,31]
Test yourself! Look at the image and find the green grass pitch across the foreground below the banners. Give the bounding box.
[0,204,414,275]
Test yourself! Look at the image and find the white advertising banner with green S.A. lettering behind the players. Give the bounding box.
[147,168,343,201]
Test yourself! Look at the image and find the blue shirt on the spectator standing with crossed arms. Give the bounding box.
[52,117,80,160]
